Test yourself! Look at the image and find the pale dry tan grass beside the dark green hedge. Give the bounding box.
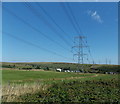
[2,83,49,102]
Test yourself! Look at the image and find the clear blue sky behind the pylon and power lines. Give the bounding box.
[2,2,118,64]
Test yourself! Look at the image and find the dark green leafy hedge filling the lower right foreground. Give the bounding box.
[18,78,120,104]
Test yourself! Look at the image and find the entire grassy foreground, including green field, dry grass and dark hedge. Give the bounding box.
[2,69,119,103]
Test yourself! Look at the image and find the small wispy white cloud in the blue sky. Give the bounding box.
[87,10,103,23]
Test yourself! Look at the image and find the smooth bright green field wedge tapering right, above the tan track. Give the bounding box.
[2,70,95,84]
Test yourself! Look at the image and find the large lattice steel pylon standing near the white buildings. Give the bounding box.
[72,36,88,72]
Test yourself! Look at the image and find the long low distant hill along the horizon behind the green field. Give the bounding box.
[0,62,120,73]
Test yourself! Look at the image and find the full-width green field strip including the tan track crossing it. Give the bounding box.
[2,70,118,84]
